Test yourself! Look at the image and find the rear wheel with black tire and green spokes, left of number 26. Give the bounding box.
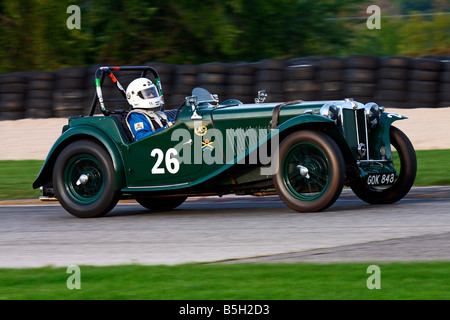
[53,140,119,218]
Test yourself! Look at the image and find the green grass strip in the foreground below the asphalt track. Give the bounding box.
[0,262,450,300]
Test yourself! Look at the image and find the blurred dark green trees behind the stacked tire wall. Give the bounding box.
[0,0,449,73]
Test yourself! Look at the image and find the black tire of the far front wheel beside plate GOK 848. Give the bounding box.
[350,127,417,204]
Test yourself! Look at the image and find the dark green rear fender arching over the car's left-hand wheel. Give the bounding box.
[33,125,126,190]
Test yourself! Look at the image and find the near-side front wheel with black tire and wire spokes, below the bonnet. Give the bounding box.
[273,130,345,212]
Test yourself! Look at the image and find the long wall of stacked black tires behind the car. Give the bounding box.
[0,55,450,120]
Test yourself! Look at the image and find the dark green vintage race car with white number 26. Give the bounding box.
[33,66,417,218]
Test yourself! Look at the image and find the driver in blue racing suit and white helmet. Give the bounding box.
[126,78,174,141]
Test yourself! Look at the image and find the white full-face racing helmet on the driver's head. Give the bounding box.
[126,78,162,109]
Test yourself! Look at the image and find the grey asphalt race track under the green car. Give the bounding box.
[0,187,450,267]
